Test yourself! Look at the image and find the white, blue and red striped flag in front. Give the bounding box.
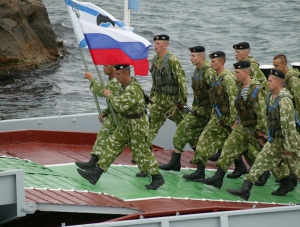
[79,19,151,76]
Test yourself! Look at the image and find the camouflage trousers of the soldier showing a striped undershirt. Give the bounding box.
[216,124,261,172]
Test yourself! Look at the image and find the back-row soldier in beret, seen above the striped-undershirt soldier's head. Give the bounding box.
[233,42,267,88]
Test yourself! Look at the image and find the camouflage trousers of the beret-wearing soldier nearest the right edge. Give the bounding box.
[244,141,292,183]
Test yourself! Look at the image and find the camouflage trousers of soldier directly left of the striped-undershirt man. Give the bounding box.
[193,118,229,166]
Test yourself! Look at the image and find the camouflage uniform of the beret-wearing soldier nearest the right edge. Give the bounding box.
[244,88,300,183]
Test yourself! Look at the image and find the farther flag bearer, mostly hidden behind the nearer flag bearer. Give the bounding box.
[75,65,121,170]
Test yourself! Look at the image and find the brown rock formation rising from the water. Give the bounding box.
[0,0,66,79]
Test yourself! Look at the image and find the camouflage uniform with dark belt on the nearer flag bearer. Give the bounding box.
[97,81,159,175]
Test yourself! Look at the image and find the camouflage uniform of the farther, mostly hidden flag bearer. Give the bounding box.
[90,78,121,155]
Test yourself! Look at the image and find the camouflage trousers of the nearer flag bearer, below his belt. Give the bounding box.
[97,115,159,175]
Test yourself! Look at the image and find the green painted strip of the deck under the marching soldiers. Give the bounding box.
[0,158,300,204]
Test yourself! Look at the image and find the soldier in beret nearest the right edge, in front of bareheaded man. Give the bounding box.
[227,69,300,200]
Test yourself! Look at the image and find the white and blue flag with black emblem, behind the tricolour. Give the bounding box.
[65,0,133,48]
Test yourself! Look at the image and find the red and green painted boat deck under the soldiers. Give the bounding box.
[0,130,300,226]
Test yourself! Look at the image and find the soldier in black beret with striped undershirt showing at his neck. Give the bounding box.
[199,61,270,188]
